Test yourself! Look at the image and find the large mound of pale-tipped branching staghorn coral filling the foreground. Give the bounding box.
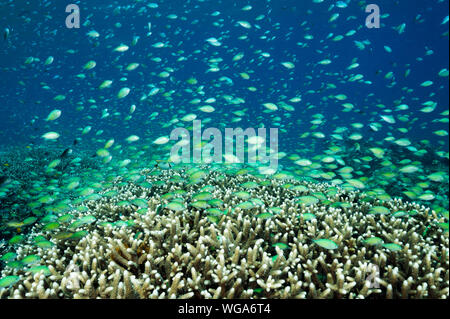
[0,169,449,298]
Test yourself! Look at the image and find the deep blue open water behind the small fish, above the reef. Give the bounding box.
[0,1,448,148]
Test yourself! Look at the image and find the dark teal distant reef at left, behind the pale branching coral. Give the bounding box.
[0,145,100,239]
